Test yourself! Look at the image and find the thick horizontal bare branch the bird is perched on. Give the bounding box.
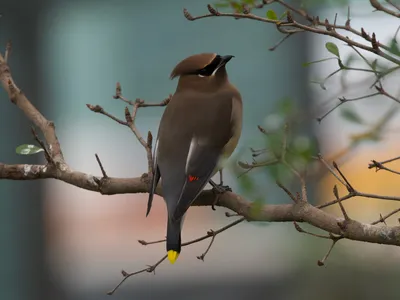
[0,164,400,246]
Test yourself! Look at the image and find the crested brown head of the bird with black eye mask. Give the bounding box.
[170,53,234,88]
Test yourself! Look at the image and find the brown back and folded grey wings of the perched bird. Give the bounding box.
[158,93,238,220]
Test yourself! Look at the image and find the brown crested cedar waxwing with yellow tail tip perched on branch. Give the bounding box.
[146,53,242,263]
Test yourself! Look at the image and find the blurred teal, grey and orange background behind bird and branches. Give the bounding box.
[0,0,400,300]
